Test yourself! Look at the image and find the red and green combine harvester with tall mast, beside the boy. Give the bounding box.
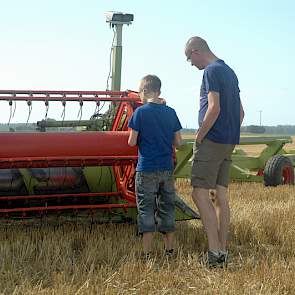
[0,13,199,222]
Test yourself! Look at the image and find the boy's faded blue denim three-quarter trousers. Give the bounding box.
[135,170,175,233]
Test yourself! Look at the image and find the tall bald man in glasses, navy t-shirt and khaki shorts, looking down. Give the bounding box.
[185,37,244,267]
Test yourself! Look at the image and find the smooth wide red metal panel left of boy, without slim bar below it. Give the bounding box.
[0,131,137,161]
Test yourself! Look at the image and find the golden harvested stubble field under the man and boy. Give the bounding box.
[0,181,295,294]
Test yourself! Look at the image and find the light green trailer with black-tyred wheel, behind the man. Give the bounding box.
[175,136,295,186]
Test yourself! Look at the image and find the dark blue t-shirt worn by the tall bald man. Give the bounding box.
[199,59,240,144]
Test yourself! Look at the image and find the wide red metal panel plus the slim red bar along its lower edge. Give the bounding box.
[0,131,137,169]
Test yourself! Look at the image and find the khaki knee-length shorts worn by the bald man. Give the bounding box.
[191,138,235,189]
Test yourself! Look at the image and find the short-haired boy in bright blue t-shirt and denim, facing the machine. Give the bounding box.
[128,75,182,257]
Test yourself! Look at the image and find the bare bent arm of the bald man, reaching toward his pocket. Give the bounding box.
[196,91,220,142]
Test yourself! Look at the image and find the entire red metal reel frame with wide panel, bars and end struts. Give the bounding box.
[0,90,141,218]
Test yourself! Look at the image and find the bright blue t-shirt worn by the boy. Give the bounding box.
[128,103,182,172]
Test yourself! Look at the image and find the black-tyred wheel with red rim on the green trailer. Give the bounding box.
[264,155,294,186]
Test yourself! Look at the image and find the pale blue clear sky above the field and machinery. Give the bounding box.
[0,0,295,128]
